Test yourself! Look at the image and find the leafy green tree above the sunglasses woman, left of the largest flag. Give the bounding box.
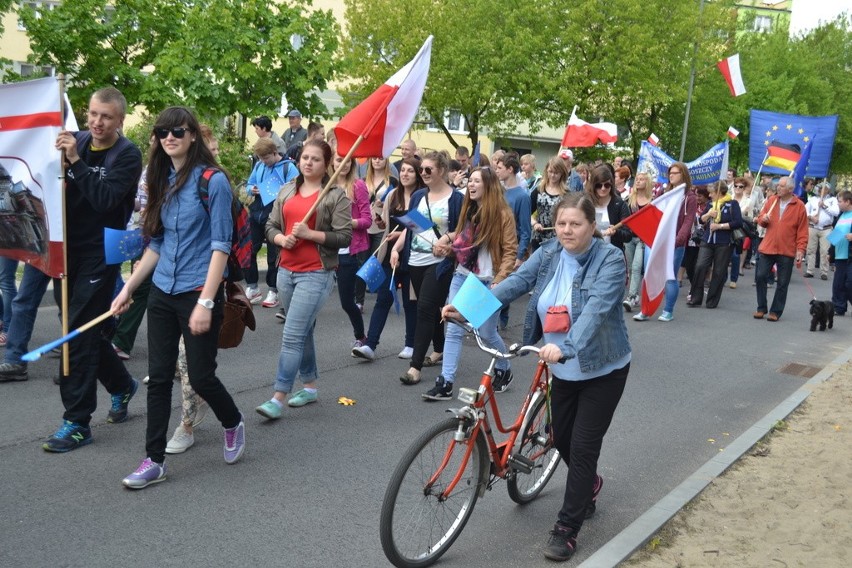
[150,0,339,133]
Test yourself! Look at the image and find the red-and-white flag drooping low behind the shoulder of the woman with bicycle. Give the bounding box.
[622,185,686,316]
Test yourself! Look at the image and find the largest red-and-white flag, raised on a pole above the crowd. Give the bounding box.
[334,36,432,158]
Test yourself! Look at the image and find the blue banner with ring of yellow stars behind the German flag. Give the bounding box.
[748,109,838,177]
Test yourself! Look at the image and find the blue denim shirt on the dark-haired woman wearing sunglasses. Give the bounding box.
[150,166,234,294]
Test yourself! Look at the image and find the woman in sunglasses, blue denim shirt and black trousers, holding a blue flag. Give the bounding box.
[112,107,245,489]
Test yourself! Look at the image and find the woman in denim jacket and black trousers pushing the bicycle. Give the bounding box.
[444,193,631,560]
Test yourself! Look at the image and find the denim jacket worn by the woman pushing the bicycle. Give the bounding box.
[491,238,631,373]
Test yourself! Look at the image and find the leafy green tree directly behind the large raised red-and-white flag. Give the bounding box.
[342,0,540,151]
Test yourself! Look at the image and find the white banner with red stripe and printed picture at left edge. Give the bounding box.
[0,77,65,277]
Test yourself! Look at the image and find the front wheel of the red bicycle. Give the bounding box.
[380,418,490,568]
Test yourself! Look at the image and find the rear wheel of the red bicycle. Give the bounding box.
[506,396,559,505]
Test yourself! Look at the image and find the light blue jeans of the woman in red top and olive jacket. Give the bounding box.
[275,268,334,393]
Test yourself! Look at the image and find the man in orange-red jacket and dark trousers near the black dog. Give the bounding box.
[754,177,808,321]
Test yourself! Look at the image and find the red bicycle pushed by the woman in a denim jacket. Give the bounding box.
[380,320,559,568]
